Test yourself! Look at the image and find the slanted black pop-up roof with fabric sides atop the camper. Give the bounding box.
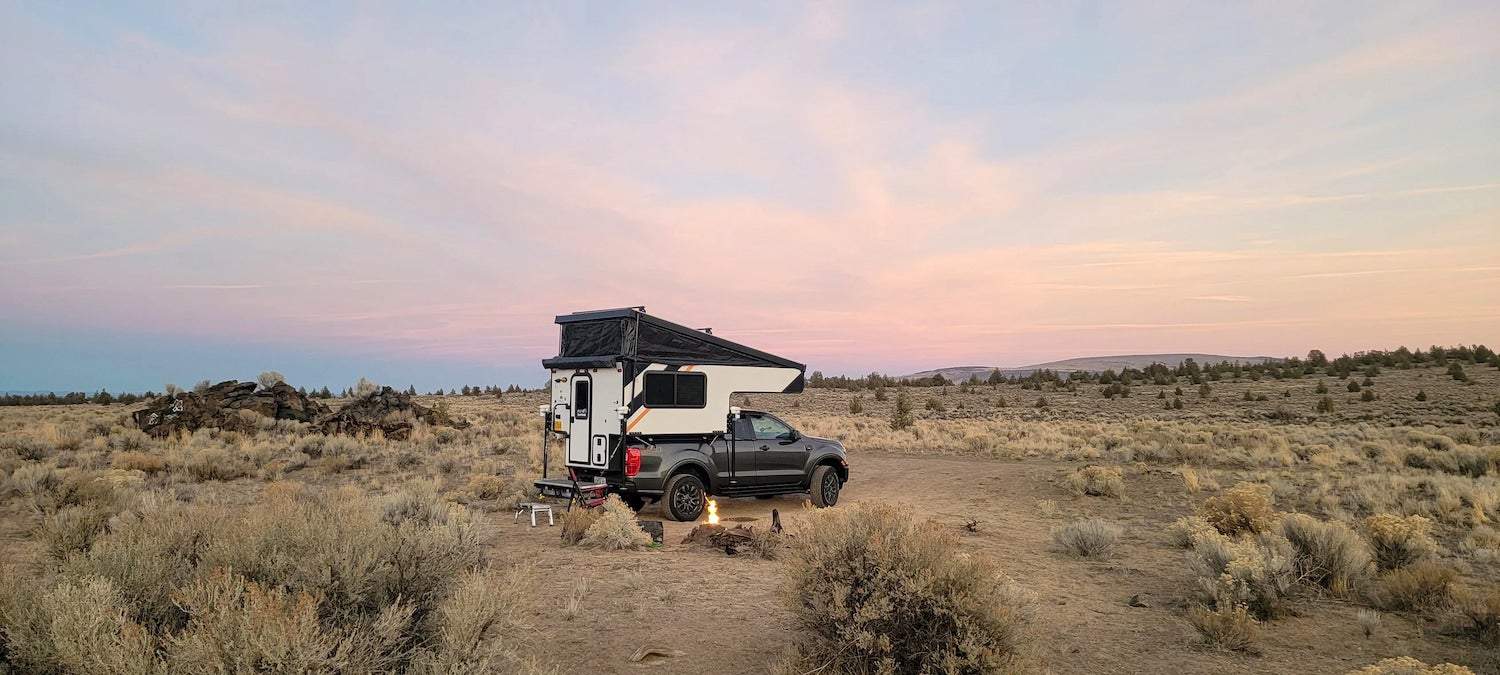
[542,308,807,376]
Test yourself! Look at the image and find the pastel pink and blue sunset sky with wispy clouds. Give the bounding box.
[0,0,1500,392]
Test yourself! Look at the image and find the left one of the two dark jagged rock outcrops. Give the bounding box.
[132,380,329,438]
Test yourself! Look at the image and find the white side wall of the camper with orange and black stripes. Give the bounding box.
[626,365,801,435]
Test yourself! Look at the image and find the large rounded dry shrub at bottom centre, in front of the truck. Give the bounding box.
[782,503,1029,674]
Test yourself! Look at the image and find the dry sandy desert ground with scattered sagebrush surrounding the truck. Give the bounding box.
[0,358,1500,674]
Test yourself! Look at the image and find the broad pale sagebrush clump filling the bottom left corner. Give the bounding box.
[0,483,518,672]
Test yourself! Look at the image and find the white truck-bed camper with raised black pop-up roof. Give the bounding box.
[542,308,807,474]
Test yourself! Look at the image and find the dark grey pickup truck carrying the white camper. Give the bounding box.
[579,410,849,521]
